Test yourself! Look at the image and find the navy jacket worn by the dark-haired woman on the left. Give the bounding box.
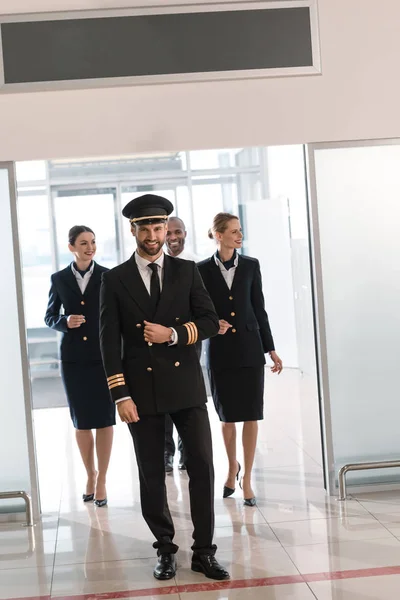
[44,263,108,362]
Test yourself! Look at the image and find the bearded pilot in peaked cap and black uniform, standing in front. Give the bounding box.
[100,194,229,579]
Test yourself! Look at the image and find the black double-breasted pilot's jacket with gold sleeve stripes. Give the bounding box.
[100,255,219,416]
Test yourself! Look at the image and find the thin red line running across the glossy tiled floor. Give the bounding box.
[6,565,400,600]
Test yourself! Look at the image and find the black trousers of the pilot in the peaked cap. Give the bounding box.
[129,405,217,554]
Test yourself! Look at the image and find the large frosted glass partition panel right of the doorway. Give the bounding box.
[314,143,400,485]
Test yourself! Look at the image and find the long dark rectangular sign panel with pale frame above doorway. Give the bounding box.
[0,1,318,87]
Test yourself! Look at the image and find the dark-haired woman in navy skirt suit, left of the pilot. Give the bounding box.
[45,225,115,506]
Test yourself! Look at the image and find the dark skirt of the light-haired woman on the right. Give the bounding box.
[208,366,264,423]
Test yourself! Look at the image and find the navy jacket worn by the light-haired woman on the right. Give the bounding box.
[198,255,274,370]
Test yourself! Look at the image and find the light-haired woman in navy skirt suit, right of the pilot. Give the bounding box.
[198,213,282,506]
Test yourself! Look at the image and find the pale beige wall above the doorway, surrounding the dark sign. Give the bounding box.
[0,0,400,160]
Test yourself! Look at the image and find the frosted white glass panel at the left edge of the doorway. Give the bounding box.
[0,163,39,518]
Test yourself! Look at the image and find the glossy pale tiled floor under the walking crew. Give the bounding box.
[0,370,400,600]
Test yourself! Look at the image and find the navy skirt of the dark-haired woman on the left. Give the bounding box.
[61,361,115,429]
